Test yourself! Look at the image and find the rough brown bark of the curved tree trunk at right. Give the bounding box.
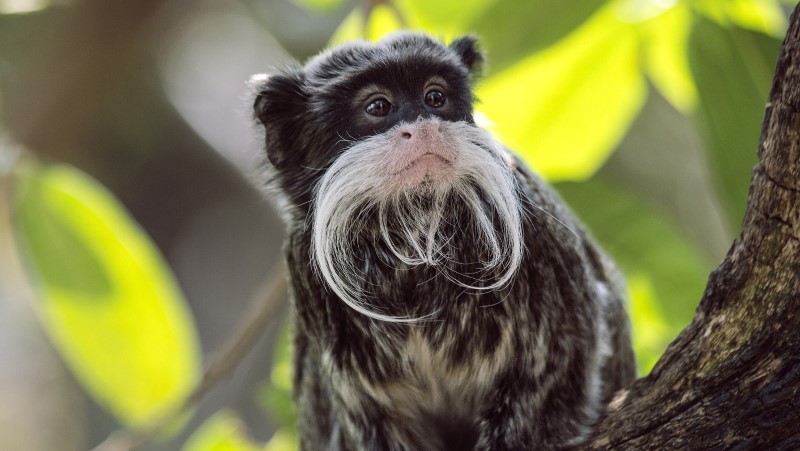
[582,6,800,450]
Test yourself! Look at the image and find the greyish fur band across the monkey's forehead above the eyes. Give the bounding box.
[304,31,468,85]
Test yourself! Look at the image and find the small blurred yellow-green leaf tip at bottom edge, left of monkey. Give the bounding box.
[182,410,263,451]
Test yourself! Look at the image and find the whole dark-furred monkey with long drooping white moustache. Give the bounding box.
[252,32,635,451]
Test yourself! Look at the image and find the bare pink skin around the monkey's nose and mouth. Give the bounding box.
[386,120,456,187]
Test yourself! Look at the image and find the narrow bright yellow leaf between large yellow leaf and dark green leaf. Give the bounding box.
[639,3,697,112]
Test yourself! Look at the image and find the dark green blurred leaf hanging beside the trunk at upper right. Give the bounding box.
[690,20,780,230]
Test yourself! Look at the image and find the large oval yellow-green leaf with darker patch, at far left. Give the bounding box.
[13,165,200,429]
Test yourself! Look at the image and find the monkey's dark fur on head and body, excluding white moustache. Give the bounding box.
[255,34,634,450]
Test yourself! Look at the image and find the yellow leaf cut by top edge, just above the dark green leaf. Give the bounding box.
[692,0,787,38]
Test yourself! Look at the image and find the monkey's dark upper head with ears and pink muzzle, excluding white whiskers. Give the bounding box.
[254,33,482,198]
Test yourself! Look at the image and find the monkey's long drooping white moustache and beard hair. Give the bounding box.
[311,122,523,322]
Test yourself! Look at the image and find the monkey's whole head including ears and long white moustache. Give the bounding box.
[254,33,522,320]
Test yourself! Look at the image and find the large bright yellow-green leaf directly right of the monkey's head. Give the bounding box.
[478,3,646,180]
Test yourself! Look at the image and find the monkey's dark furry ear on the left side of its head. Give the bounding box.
[251,69,308,167]
